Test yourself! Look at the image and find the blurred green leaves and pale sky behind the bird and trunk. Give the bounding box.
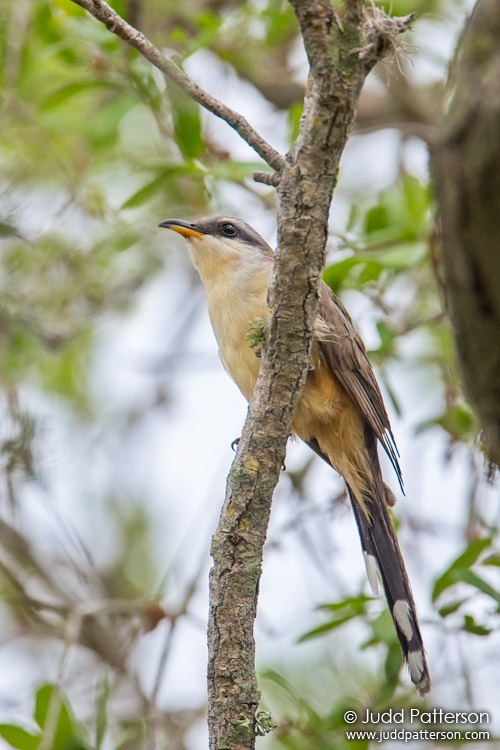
[0,0,500,750]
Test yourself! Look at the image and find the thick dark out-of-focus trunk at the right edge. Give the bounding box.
[433,0,500,464]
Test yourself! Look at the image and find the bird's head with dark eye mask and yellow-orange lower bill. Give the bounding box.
[160,216,274,279]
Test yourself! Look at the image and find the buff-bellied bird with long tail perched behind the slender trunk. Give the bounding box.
[159,215,430,696]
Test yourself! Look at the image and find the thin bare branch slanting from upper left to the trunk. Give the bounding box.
[72,0,283,171]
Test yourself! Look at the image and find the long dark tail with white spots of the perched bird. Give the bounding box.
[308,435,431,695]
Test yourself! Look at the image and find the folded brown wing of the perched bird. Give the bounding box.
[316,282,403,489]
